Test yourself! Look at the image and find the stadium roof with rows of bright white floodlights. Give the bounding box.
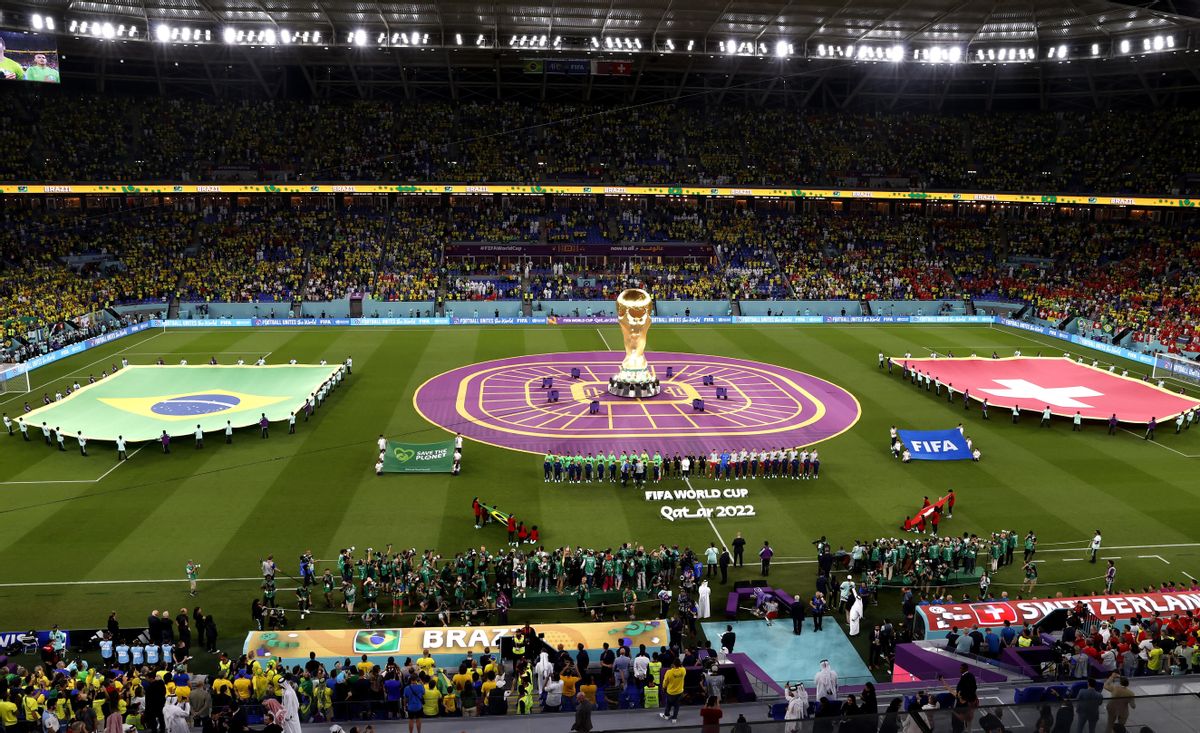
[2,0,1200,109]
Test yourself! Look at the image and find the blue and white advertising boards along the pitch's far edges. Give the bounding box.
[0,316,1171,391]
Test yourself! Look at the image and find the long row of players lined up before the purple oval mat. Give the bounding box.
[541,447,821,487]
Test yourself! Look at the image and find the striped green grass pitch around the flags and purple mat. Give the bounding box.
[0,325,1200,667]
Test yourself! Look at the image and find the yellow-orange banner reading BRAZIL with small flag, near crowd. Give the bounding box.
[242,620,667,666]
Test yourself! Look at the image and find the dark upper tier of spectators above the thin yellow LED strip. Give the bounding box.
[7,88,1200,194]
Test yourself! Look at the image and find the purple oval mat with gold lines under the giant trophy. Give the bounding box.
[413,352,860,453]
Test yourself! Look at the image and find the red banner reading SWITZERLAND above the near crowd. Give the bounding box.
[917,590,1200,638]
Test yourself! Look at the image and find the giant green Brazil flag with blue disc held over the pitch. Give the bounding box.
[24,364,340,441]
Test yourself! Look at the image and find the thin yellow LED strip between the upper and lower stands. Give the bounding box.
[0,182,1195,209]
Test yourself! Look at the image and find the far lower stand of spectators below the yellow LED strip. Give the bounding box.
[0,197,1200,359]
